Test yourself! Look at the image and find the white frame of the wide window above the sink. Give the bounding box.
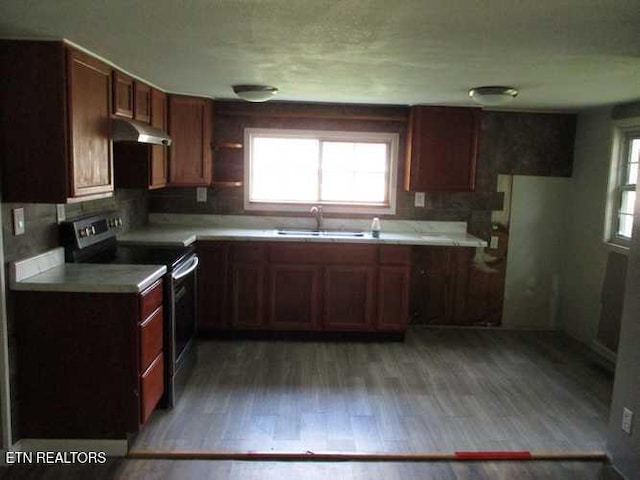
[244,128,400,215]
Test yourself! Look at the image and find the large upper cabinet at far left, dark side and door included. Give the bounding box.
[0,41,113,203]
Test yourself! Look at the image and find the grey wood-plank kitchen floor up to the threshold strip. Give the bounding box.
[134,328,612,456]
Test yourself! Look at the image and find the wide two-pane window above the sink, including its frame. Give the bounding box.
[245,128,398,214]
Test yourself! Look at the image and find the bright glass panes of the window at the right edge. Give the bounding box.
[607,125,640,248]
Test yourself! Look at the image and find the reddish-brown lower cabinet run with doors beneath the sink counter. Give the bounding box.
[198,241,411,333]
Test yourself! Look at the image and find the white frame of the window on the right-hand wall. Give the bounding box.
[604,118,640,253]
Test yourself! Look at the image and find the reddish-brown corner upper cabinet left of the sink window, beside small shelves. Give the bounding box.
[168,95,212,187]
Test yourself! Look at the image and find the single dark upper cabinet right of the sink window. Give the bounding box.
[405,106,480,192]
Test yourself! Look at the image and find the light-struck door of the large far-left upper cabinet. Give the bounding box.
[68,50,113,197]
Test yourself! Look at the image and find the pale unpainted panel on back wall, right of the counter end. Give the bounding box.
[502,175,570,328]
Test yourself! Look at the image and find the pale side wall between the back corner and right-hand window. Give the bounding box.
[559,108,612,344]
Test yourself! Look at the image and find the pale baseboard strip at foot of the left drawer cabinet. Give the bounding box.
[12,438,129,457]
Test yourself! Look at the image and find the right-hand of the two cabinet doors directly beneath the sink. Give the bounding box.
[322,265,375,331]
